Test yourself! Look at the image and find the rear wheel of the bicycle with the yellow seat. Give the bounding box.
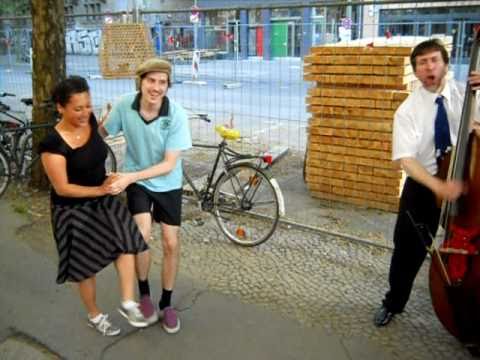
[213,164,280,246]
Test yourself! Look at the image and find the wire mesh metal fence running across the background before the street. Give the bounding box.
[0,10,471,152]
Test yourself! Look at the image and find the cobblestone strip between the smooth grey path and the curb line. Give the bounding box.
[152,214,470,359]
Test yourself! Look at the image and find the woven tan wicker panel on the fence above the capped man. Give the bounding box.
[98,23,155,79]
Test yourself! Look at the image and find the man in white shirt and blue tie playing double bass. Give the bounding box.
[374,39,480,326]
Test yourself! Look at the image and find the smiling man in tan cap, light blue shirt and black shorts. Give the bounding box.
[99,58,192,334]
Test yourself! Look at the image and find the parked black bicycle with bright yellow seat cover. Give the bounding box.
[182,117,285,246]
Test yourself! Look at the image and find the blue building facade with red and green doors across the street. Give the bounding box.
[61,0,480,60]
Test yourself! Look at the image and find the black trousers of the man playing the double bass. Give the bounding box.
[383,177,440,313]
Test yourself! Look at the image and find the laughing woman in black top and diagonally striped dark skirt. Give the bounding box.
[39,76,148,336]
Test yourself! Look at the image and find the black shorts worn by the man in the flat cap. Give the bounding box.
[126,184,182,226]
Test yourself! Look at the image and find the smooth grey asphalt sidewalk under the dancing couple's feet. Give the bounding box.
[0,200,389,360]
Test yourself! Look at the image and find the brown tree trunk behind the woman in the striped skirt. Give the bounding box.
[31,0,65,189]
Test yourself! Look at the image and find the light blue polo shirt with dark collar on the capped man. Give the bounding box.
[104,93,192,192]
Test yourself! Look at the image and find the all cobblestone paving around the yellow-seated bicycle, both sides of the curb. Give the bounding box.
[108,136,470,360]
